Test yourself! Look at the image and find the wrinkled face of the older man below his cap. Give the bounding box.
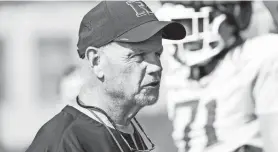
[100,33,163,106]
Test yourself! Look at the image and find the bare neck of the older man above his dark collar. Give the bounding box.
[79,87,142,126]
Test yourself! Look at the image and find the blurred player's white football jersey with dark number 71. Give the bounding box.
[164,34,278,152]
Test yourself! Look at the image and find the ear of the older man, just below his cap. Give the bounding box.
[85,46,104,79]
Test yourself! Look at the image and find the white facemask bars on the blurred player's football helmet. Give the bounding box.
[163,5,226,66]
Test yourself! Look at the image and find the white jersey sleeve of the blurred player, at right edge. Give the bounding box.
[253,34,278,114]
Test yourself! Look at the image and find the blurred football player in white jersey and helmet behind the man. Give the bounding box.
[157,1,278,152]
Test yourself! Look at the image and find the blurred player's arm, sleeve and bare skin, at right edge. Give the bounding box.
[253,55,278,152]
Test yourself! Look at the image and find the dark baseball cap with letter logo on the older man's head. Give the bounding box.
[77,0,186,58]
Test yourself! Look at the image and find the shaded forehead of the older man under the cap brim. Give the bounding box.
[117,32,163,52]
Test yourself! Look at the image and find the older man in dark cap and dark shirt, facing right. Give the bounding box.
[27,1,185,152]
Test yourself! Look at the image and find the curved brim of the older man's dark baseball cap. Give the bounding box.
[115,21,186,42]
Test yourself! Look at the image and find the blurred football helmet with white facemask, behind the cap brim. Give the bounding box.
[156,1,252,66]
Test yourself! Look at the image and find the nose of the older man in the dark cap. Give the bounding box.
[146,52,163,77]
